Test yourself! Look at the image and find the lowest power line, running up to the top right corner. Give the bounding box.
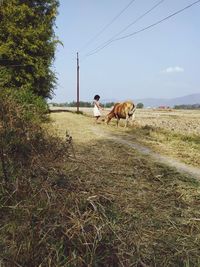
[86,0,200,56]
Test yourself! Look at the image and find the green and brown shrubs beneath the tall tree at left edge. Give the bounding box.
[0,89,55,180]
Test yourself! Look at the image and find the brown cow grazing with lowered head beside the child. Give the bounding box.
[106,101,136,127]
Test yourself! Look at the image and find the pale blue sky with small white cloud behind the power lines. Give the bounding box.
[52,0,200,103]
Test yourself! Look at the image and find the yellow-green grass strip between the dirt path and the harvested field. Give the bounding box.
[128,126,200,167]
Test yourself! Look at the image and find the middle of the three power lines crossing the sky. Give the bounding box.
[84,0,165,57]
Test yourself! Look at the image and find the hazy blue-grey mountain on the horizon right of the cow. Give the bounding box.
[135,93,200,107]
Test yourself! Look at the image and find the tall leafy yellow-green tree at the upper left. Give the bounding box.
[0,0,59,97]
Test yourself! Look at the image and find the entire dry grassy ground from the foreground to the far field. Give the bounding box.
[0,109,200,267]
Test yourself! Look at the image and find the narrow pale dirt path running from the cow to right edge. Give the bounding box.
[92,127,200,180]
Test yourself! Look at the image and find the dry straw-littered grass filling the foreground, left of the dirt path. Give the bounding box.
[0,110,200,267]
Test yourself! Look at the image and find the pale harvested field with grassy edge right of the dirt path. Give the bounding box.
[52,108,200,167]
